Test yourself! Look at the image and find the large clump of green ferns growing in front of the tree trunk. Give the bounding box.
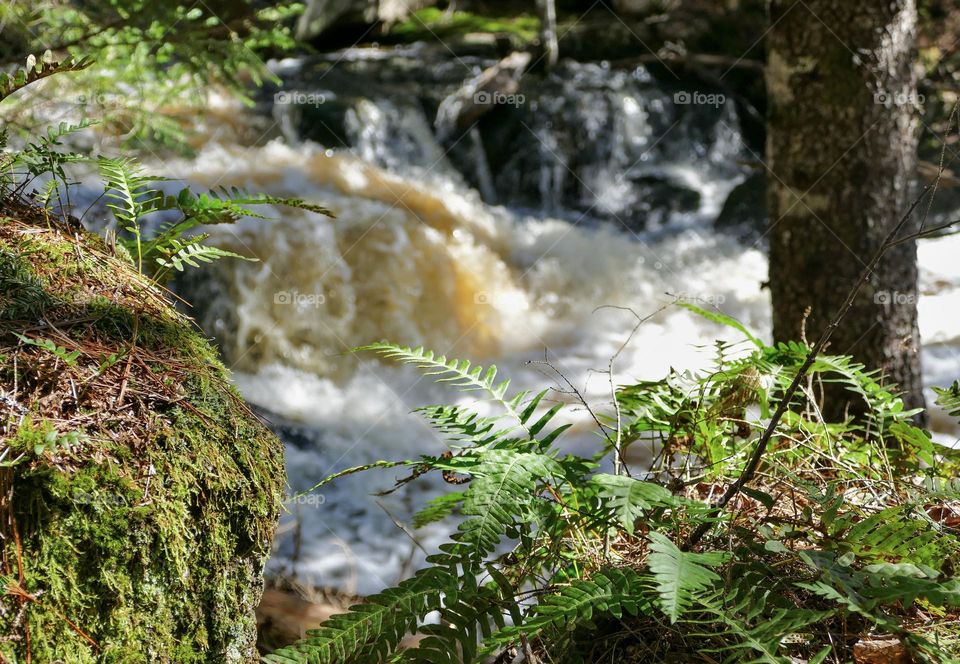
[267,307,960,664]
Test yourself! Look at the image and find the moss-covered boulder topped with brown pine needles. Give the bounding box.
[0,206,284,664]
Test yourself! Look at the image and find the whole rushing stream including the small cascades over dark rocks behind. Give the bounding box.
[167,49,960,593]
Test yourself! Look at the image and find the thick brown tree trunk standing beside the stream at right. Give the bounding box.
[766,0,923,420]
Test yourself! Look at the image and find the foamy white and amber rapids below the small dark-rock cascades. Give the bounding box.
[167,126,960,593]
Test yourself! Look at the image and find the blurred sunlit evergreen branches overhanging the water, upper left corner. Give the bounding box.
[0,0,303,149]
